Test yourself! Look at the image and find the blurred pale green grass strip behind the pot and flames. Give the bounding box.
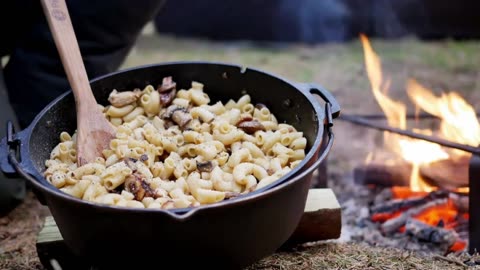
[122,30,480,113]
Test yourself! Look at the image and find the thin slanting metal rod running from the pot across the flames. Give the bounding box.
[338,114,480,156]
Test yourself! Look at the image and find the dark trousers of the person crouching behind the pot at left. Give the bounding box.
[0,0,165,215]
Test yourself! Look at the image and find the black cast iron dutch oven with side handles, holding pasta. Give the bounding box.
[0,62,340,269]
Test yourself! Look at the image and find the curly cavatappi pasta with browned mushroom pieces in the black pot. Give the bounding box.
[44,77,307,209]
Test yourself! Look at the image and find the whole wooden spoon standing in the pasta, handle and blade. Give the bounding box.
[42,0,115,166]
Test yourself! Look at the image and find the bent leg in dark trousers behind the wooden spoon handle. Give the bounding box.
[5,0,164,127]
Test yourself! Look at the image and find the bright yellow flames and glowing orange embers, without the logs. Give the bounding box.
[360,35,470,251]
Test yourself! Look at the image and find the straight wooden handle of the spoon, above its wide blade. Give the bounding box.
[41,0,96,106]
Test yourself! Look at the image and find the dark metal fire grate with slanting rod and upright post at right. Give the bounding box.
[338,114,480,254]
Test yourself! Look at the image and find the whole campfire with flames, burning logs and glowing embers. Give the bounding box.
[348,35,472,252]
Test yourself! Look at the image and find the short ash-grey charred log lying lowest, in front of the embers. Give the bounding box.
[405,218,458,246]
